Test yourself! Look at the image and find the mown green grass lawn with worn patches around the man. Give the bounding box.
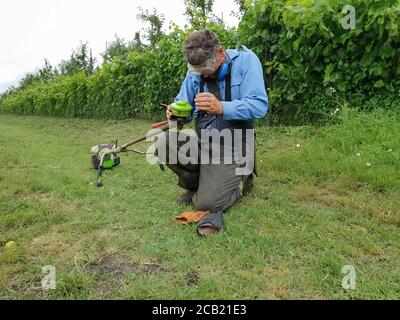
[0,110,400,299]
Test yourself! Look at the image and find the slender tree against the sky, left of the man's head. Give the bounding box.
[137,7,165,48]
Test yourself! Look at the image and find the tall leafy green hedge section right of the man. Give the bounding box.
[239,0,400,122]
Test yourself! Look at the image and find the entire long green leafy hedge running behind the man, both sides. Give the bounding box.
[0,0,400,121]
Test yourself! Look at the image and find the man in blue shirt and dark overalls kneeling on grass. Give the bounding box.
[157,29,268,236]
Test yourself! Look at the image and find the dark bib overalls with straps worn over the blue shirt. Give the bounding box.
[157,64,255,220]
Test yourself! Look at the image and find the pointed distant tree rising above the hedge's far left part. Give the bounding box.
[59,42,96,75]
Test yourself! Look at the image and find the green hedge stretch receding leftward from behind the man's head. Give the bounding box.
[0,26,237,119]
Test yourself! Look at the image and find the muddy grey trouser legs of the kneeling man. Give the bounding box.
[156,132,249,212]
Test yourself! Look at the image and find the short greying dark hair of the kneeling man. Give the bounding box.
[183,29,221,65]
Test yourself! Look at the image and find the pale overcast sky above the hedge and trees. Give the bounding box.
[0,0,238,92]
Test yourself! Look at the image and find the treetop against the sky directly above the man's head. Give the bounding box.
[184,0,214,30]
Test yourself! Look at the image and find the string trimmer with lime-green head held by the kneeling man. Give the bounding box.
[91,101,192,187]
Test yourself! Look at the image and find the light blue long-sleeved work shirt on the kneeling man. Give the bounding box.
[175,46,268,120]
